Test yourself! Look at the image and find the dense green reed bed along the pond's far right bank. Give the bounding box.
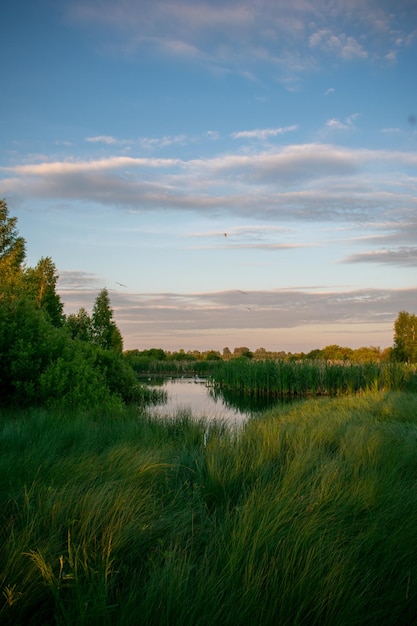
[212,359,417,398]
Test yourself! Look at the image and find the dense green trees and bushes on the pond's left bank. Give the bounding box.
[0,200,154,410]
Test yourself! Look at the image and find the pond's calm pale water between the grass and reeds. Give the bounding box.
[146,377,254,424]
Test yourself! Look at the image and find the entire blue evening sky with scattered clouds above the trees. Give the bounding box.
[0,0,417,352]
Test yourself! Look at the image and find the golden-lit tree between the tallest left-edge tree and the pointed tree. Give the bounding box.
[25,257,64,326]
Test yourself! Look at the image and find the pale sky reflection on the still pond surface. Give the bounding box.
[149,378,249,423]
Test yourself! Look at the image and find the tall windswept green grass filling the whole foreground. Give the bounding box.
[0,392,417,626]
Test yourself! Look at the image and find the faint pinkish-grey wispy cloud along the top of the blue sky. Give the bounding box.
[66,0,416,80]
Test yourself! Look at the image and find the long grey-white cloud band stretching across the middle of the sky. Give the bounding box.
[0,143,417,223]
